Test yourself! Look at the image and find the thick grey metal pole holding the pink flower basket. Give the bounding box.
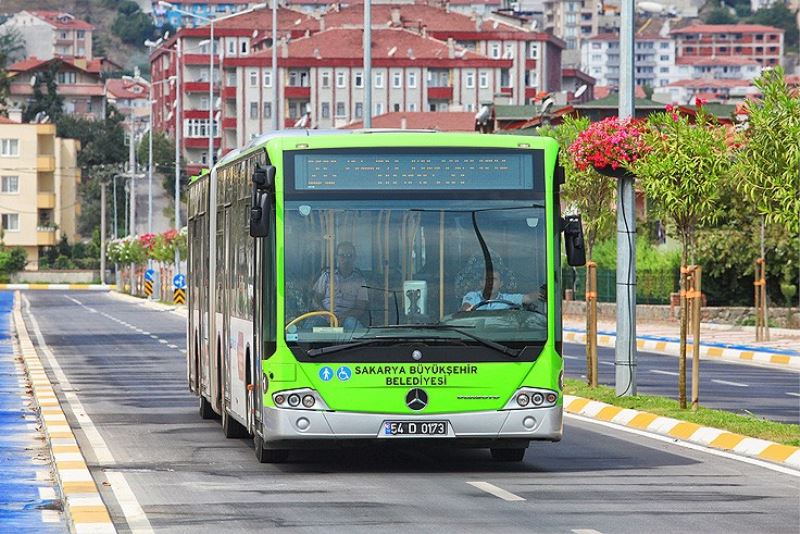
[614,0,636,397]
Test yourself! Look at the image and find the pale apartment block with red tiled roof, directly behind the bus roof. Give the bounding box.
[222,28,513,151]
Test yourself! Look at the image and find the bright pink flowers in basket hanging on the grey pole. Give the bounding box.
[568,117,647,170]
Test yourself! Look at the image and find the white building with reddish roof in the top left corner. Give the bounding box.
[3,10,95,60]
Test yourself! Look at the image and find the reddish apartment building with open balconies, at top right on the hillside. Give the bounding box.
[670,24,784,67]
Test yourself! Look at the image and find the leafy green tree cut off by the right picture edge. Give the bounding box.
[734,67,800,236]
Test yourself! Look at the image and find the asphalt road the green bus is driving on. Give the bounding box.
[18,292,800,534]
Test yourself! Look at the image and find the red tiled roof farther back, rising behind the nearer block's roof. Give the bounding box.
[323,2,526,34]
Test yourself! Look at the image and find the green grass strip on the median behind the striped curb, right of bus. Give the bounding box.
[564,378,800,447]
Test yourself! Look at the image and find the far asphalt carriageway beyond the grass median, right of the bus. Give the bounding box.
[564,343,800,424]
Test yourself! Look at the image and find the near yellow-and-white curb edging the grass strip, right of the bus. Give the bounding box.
[564,395,800,471]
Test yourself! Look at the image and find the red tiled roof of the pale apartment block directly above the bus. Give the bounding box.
[252,28,498,61]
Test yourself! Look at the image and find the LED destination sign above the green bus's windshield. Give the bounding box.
[293,150,534,191]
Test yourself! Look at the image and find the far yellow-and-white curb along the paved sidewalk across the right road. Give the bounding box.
[564,331,800,370]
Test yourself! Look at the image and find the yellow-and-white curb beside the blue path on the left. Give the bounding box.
[13,293,117,534]
